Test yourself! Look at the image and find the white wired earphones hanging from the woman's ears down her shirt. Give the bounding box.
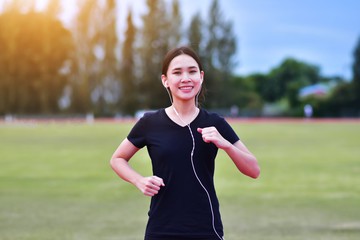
[164,85,225,240]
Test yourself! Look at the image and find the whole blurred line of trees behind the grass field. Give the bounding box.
[0,0,360,116]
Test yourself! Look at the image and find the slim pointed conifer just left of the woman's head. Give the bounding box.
[118,10,139,115]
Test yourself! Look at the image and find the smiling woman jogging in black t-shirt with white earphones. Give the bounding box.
[111,47,260,240]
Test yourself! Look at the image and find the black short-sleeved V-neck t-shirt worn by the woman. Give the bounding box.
[127,109,239,238]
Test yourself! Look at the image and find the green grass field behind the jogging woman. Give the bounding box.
[0,122,360,240]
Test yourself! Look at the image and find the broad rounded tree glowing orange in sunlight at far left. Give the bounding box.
[0,9,73,114]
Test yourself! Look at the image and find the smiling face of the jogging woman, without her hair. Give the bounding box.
[162,54,204,100]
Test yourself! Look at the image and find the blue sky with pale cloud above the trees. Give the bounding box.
[120,0,360,79]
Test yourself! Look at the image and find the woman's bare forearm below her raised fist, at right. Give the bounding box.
[224,142,260,178]
